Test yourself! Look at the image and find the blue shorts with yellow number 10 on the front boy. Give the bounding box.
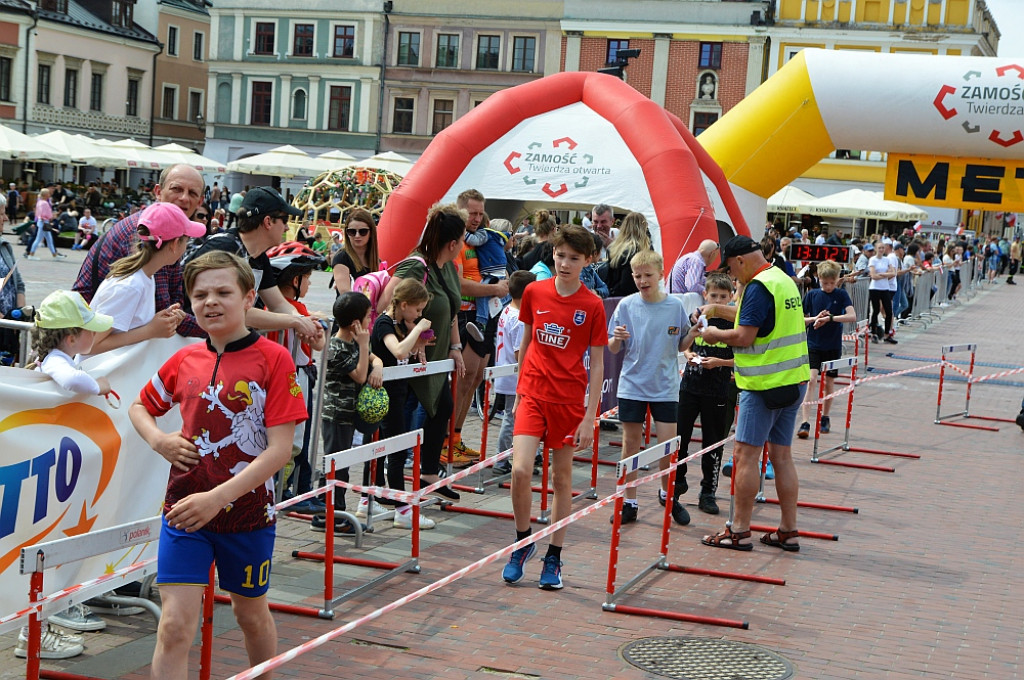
[157,518,276,597]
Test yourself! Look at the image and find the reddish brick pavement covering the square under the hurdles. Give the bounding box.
[0,248,1024,680]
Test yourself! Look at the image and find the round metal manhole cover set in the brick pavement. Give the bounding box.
[622,636,794,680]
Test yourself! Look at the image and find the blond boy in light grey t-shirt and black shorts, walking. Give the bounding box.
[608,250,690,524]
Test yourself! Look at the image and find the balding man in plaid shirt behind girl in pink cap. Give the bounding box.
[72,164,206,337]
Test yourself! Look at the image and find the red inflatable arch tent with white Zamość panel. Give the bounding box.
[379,72,750,266]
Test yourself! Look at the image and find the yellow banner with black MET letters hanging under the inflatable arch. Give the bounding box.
[886,154,1024,212]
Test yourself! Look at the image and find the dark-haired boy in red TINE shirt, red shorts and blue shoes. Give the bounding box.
[502,225,608,590]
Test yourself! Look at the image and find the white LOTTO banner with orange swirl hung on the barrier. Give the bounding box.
[0,337,194,617]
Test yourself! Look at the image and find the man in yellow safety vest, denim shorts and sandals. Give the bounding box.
[695,236,810,552]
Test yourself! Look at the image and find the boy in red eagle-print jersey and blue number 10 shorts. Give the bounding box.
[129,251,306,680]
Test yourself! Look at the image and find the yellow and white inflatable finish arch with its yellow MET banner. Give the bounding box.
[698,49,1024,226]
